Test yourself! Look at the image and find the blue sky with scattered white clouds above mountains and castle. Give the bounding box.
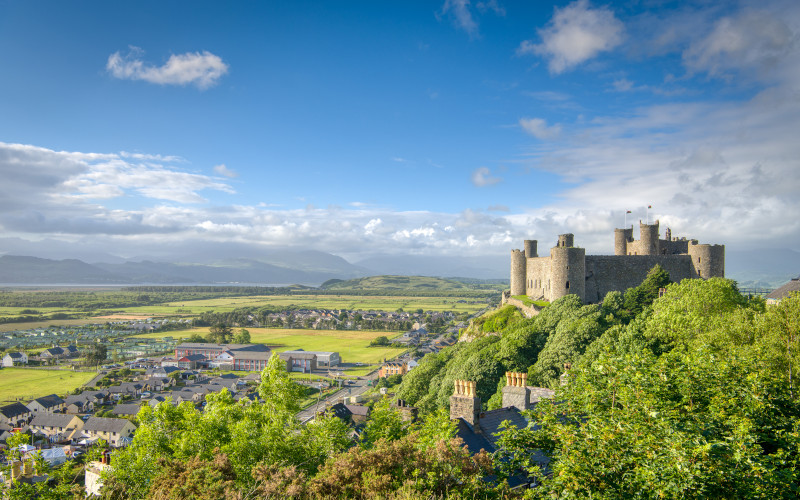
[0,0,800,262]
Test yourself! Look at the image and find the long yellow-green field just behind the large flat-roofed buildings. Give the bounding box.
[136,328,405,363]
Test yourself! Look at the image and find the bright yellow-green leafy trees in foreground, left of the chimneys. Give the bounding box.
[103,355,347,499]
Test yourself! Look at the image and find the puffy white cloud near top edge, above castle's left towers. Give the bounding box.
[517,0,624,74]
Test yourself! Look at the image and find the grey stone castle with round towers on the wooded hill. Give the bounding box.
[503,221,725,304]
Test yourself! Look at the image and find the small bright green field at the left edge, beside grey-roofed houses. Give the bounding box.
[0,368,96,403]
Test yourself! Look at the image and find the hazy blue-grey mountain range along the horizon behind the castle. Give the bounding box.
[0,249,800,288]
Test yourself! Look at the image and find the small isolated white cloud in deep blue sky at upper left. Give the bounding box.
[106,47,228,89]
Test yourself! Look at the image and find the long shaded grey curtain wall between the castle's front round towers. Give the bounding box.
[584,255,694,304]
